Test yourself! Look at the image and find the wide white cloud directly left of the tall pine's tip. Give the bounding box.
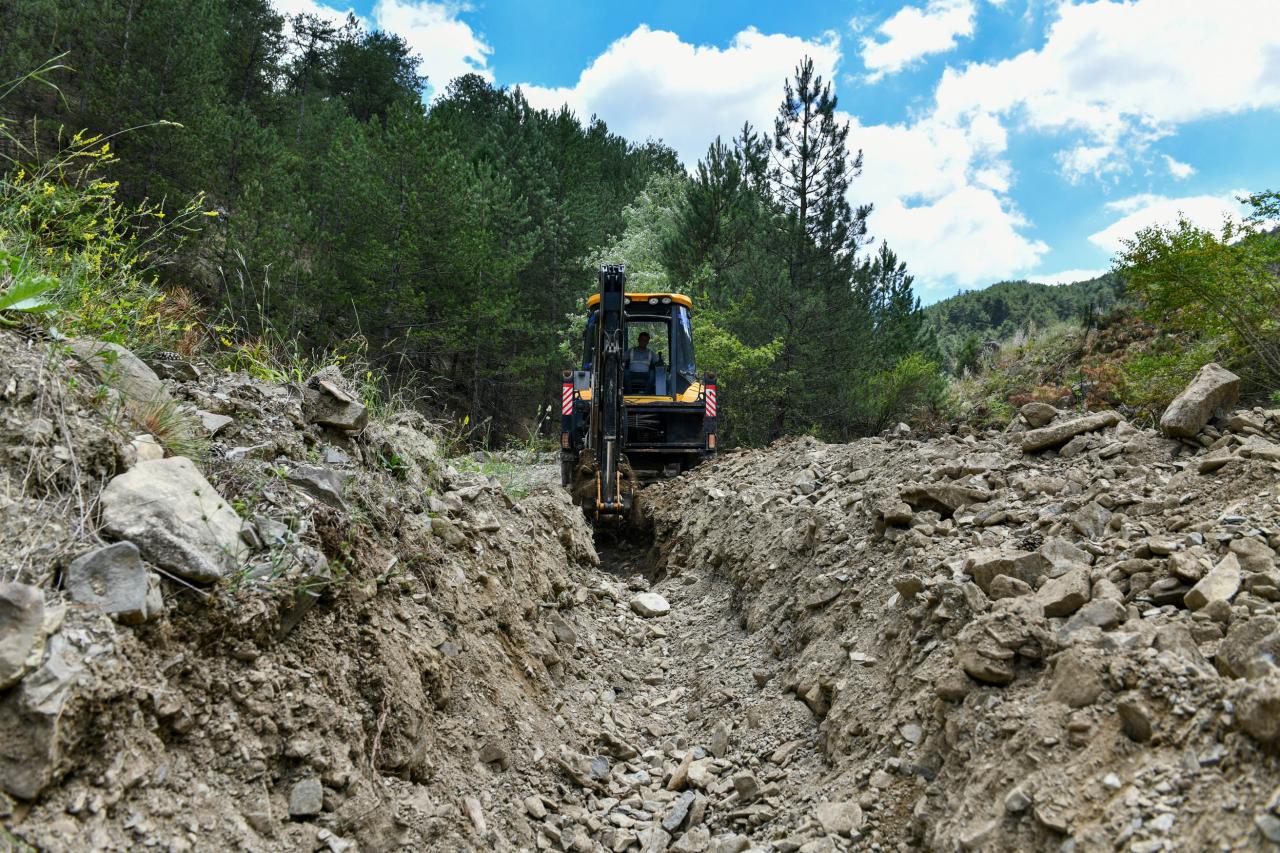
[521,26,840,164]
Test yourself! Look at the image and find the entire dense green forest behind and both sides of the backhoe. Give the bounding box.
[0,0,942,443]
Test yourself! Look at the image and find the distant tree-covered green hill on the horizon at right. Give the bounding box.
[924,273,1120,343]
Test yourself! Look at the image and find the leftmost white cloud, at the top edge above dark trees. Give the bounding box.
[271,0,493,96]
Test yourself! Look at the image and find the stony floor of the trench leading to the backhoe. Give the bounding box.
[501,543,878,852]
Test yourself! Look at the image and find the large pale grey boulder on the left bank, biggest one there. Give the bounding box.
[101,456,247,583]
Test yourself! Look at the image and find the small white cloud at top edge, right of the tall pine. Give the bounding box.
[861,0,975,82]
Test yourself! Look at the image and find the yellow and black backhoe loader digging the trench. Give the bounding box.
[561,265,717,521]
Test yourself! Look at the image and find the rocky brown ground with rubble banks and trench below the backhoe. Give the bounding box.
[0,332,1280,853]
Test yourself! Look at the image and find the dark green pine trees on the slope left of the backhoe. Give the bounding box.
[0,0,676,432]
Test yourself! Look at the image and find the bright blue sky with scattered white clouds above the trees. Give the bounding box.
[274,0,1280,302]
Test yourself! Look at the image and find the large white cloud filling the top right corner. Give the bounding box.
[936,0,1280,179]
